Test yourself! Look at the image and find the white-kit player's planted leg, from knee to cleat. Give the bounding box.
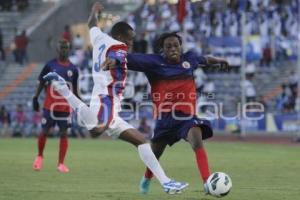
[119,129,188,194]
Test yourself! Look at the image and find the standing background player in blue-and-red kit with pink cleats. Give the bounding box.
[33,40,78,173]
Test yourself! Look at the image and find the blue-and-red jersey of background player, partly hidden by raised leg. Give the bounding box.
[39,59,78,112]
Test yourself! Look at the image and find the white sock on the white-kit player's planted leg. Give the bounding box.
[138,144,170,185]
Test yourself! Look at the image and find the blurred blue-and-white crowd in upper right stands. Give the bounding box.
[127,0,298,53]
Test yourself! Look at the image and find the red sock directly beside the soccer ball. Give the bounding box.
[195,148,210,183]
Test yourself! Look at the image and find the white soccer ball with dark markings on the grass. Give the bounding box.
[206,172,232,197]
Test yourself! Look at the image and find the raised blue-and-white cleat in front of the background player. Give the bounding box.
[43,72,69,94]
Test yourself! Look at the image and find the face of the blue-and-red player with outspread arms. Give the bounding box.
[163,37,181,63]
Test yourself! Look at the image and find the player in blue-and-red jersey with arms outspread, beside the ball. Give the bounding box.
[104,33,228,193]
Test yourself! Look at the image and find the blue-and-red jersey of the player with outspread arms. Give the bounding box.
[127,51,207,115]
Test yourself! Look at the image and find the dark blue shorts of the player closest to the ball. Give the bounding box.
[151,112,213,146]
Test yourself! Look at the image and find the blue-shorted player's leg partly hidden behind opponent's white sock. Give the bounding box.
[139,141,167,194]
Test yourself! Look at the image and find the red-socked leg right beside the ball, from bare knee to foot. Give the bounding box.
[187,127,210,193]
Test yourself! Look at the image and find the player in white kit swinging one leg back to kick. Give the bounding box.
[45,3,188,194]
